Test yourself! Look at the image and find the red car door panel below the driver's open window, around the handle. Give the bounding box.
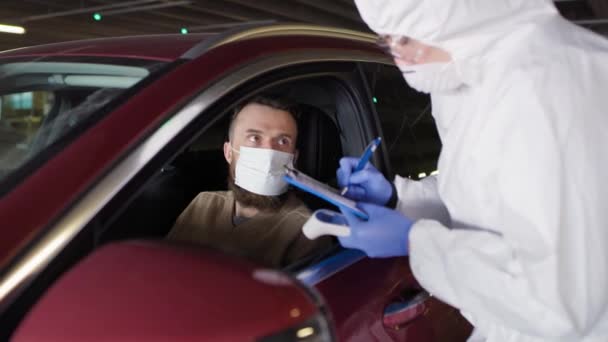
[297,250,471,342]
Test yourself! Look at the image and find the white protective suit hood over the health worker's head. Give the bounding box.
[355,0,559,60]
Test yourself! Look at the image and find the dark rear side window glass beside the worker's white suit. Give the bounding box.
[364,64,441,179]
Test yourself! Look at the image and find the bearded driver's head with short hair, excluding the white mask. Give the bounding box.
[224,103,298,210]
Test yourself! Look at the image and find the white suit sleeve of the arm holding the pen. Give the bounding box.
[394,176,450,225]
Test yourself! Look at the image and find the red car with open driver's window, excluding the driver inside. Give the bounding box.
[0,25,470,342]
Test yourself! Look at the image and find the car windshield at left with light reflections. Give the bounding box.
[0,57,164,187]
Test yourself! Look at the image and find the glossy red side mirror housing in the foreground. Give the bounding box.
[12,241,318,341]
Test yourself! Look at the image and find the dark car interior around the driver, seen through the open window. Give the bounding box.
[94,74,360,271]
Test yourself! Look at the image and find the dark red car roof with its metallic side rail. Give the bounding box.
[0,24,374,62]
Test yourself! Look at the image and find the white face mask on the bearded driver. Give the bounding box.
[233,146,294,196]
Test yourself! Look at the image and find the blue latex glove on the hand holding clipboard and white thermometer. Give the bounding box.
[338,203,413,258]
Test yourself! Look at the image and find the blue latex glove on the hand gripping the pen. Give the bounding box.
[336,157,393,205]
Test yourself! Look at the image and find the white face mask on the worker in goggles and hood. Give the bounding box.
[399,63,464,93]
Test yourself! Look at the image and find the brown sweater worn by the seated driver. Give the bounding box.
[167,191,332,267]
